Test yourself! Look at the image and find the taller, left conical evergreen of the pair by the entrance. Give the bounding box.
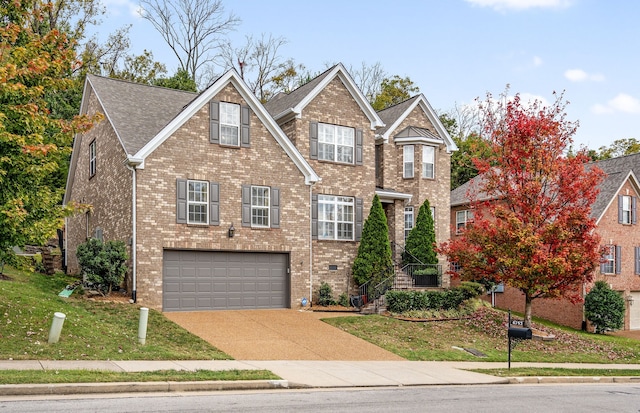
[351,195,393,285]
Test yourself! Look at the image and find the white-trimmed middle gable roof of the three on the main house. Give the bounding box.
[265,63,384,130]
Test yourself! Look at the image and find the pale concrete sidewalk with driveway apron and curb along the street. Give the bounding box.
[0,360,640,396]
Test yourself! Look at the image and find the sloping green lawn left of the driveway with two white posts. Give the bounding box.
[0,266,231,360]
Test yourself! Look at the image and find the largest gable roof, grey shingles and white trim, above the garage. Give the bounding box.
[63,70,320,204]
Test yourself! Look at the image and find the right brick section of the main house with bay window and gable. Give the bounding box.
[376,94,457,287]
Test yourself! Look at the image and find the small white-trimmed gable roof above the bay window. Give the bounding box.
[376,93,458,153]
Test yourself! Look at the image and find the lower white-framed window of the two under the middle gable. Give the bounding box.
[318,195,355,241]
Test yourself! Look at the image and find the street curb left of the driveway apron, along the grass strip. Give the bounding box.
[0,380,289,396]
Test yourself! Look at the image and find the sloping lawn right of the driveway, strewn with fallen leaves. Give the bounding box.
[324,307,640,363]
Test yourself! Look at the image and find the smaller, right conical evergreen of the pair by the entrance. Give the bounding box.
[402,199,438,265]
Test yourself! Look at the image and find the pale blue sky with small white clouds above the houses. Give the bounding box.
[98,0,640,149]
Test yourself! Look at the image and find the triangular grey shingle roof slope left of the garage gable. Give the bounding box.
[87,75,198,155]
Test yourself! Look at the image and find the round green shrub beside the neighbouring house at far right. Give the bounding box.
[584,281,624,334]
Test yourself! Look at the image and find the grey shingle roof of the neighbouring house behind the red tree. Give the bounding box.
[450,153,640,223]
